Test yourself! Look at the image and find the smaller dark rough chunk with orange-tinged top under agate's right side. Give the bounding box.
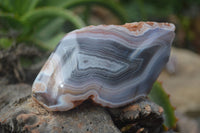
[109,99,164,133]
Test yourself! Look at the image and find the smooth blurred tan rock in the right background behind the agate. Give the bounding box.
[158,48,200,113]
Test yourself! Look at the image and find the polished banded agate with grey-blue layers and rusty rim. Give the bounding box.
[32,22,175,111]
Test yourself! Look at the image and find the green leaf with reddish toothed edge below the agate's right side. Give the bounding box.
[148,82,177,128]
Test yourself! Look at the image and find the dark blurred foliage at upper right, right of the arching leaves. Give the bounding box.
[120,0,200,54]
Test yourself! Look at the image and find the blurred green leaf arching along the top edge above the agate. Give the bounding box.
[62,0,127,23]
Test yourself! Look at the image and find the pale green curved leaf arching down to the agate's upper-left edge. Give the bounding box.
[21,7,85,28]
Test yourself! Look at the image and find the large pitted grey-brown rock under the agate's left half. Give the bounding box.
[0,84,120,133]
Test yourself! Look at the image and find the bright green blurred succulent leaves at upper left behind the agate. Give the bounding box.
[0,0,126,50]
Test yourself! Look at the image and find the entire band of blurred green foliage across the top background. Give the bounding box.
[0,0,200,53]
